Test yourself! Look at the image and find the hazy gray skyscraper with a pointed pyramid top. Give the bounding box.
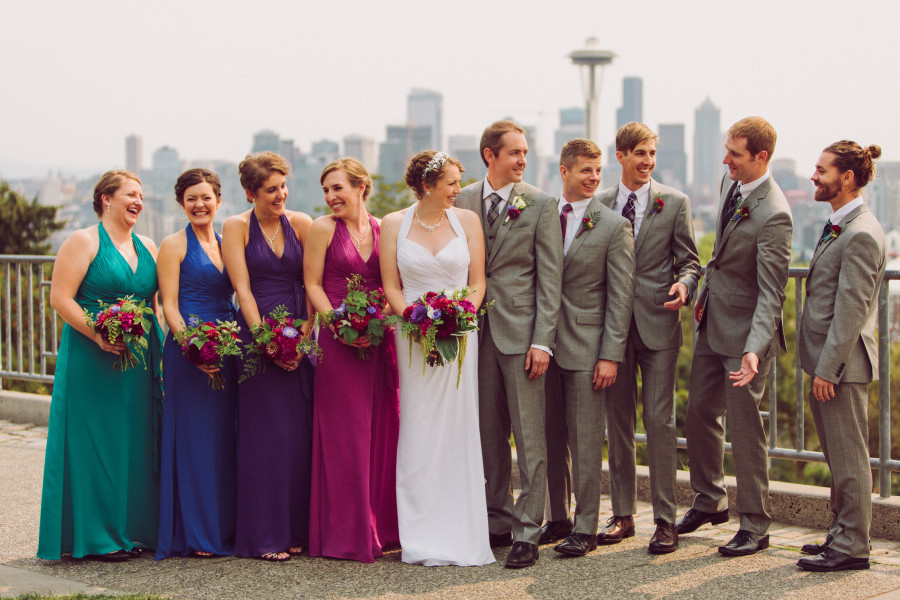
[693,97,724,206]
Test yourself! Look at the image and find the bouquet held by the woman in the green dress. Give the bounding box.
[84,296,153,371]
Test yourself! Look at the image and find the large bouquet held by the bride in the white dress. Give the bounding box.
[401,287,491,388]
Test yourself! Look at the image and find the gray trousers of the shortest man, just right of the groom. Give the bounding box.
[547,358,607,535]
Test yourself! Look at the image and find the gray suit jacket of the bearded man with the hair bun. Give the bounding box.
[798,205,885,383]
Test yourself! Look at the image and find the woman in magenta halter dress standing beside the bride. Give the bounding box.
[304,158,400,563]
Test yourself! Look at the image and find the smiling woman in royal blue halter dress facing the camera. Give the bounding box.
[156,169,237,560]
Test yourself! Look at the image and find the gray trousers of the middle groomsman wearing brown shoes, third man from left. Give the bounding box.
[606,320,678,523]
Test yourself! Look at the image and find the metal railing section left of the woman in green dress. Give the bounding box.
[0,254,61,389]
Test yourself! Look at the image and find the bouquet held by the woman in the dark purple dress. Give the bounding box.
[238,305,320,382]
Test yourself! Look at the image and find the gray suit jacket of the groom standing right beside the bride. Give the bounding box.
[456,181,562,354]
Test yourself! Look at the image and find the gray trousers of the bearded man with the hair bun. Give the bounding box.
[809,383,872,558]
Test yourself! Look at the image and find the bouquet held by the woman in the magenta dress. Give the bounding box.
[318,275,398,358]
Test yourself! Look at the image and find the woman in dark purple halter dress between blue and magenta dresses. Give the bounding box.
[222,152,313,562]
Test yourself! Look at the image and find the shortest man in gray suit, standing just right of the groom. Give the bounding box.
[545,139,634,556]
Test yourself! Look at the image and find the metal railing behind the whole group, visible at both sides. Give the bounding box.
[0,255,900,498]
